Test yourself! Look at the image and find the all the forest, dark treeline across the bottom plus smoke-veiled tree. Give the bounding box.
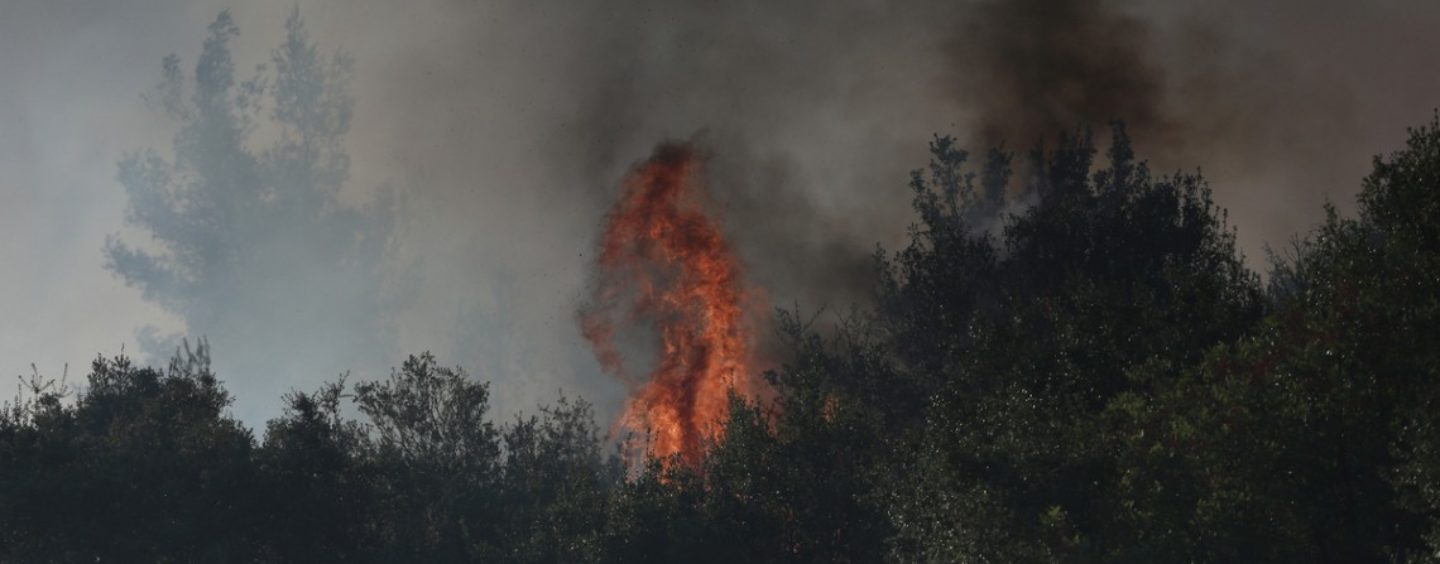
[8,8,1440,563]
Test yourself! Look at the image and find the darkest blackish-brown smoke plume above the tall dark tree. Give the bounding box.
[950,0,1171,148]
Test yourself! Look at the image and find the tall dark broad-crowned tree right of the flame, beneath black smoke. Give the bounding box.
[800,125,1261,560]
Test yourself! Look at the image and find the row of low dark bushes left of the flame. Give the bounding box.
[0,344,624,563]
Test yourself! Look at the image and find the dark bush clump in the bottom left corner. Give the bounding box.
[0,342,256,561]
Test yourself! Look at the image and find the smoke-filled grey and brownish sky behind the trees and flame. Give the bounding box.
[0,0,1440,426]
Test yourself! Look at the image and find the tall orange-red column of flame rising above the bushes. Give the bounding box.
[580,144,763,465]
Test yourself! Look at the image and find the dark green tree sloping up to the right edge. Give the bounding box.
[1113,116,1440,561]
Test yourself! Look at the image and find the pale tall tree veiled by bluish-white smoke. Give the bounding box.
[105,10,395,405]
